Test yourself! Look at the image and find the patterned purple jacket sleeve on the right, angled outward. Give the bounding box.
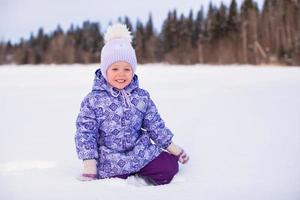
[142,94,173,149]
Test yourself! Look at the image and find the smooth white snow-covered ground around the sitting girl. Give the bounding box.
[0,64,300,200]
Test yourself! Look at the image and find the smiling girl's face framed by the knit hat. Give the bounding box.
[106,61,133,90]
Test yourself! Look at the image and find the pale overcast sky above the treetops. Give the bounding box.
[0,0,263,42]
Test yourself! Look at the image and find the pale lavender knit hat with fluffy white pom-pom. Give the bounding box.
[100,24,137,80]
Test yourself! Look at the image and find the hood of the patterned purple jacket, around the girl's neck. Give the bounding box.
[92,69,139,96]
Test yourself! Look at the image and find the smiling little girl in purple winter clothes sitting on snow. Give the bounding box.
[75,24,189,185]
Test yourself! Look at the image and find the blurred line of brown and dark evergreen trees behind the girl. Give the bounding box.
[0,0,300,65]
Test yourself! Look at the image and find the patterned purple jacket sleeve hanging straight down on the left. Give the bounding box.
[75,95,99,160]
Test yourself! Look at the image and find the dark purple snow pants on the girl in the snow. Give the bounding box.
[116,151,178,185]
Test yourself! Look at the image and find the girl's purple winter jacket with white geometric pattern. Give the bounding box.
[75,70,173,178]
